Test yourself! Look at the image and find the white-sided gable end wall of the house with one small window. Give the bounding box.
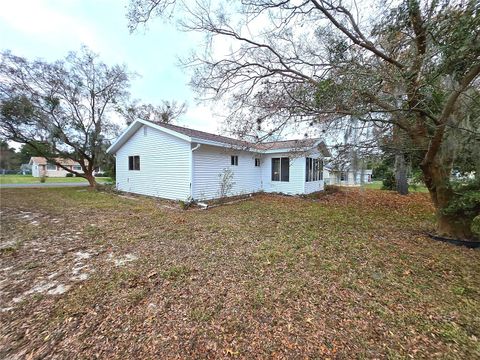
[116,126,192,200]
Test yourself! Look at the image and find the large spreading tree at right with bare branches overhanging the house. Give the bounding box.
[128,0,480,238]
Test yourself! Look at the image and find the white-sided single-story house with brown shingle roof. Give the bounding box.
[107,120,330,200]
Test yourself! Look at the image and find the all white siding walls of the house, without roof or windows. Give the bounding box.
[110,122,324,200]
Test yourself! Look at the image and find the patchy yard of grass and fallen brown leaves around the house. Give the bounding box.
[0,188,480,359]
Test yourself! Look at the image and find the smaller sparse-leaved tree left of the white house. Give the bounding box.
[0,47,130,187]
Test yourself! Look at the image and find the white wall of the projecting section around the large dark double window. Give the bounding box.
[262,153,305,195]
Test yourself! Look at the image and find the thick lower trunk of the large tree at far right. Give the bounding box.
[421,160,472,239]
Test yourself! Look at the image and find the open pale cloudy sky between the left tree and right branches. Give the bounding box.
[0,0,226,133]
